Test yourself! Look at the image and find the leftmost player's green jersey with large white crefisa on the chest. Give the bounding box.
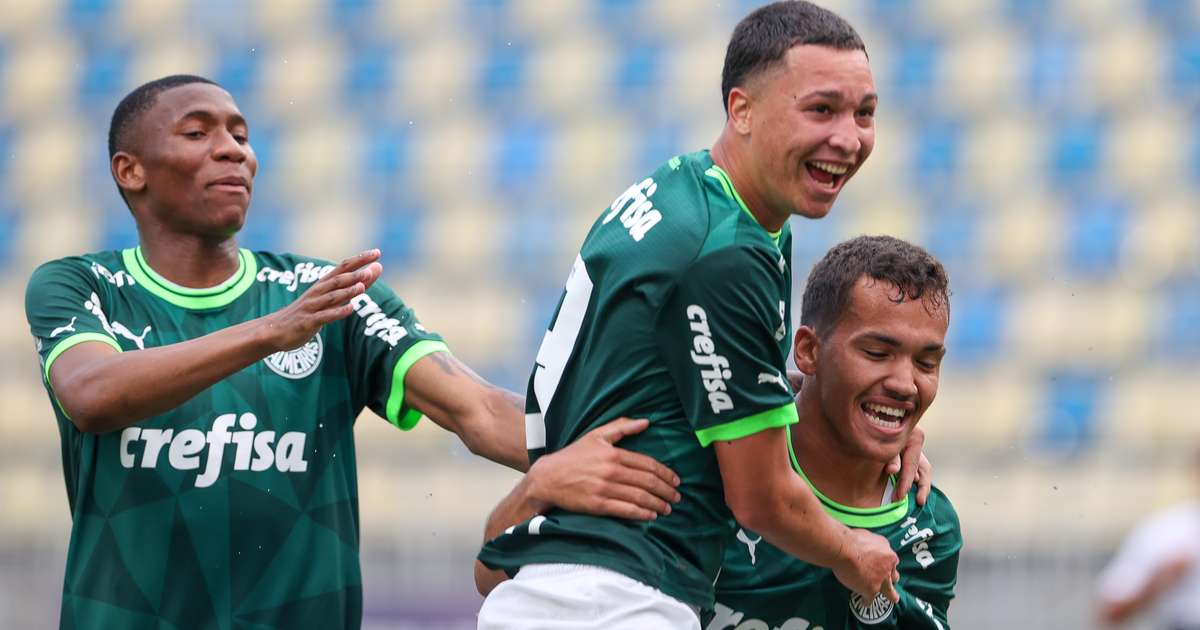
[25,248,445,630]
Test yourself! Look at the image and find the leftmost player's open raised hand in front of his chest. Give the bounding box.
[263,250,383,352]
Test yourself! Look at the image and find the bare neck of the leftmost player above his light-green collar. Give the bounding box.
[138,229,240,289]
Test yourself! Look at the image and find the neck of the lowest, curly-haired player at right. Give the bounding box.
[792,388,888,508]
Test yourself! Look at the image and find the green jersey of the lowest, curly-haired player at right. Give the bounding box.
[701,432,962,630]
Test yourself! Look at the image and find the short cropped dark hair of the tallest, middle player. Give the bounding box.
[721,0,866,114]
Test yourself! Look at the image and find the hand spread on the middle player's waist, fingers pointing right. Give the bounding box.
[526,418,679,521]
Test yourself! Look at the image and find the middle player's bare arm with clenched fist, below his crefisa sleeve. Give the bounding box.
[713,428,899,601]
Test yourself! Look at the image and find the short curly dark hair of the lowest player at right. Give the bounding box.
[800,236,950,337]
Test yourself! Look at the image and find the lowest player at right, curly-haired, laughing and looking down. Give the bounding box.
[703,236,962,630]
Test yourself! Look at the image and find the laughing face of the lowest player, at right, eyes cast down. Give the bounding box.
[794,276,949,463]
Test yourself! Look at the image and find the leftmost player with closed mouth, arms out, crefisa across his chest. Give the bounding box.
[25,76,674,630]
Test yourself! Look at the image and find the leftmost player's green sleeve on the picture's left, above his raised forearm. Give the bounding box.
[25,258,126,384]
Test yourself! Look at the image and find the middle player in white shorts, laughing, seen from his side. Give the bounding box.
[479,1,912,629]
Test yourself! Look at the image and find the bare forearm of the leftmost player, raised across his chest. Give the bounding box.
[50,320,275,433]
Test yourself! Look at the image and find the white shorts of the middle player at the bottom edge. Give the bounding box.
[479,564,700,630]
